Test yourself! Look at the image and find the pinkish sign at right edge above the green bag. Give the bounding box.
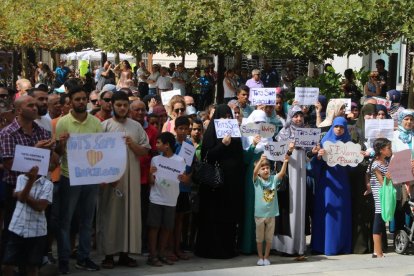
[388,149,414,184]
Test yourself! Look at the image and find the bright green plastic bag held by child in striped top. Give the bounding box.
[379,177,397,222]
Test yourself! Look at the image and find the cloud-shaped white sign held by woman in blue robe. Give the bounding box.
[322,141,364,167]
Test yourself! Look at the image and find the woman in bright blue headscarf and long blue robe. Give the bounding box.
[311,117,352,255]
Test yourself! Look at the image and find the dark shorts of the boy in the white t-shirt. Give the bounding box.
[147,202,175,230]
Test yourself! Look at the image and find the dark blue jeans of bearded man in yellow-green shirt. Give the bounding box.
[53,176,98,261]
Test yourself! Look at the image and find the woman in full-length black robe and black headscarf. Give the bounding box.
[195,104,244,259]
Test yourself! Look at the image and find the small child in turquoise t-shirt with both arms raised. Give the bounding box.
[253,154,289,266]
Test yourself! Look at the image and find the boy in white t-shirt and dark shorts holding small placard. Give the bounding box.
[147,132,187,266]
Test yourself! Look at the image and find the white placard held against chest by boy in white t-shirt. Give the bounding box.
[154,155,185,182]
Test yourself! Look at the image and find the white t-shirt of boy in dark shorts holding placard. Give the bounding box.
[150,154,185,207]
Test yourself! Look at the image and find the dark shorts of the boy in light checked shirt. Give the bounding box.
[3,232,47,266]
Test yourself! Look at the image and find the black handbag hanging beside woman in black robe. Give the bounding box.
[194,152,224,190]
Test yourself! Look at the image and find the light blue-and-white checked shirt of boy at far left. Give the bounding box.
[9,177,53,238]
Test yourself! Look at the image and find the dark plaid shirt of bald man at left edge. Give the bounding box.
[0,119,50,186]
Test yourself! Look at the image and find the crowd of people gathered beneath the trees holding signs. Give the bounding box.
[0,58,414,275]
